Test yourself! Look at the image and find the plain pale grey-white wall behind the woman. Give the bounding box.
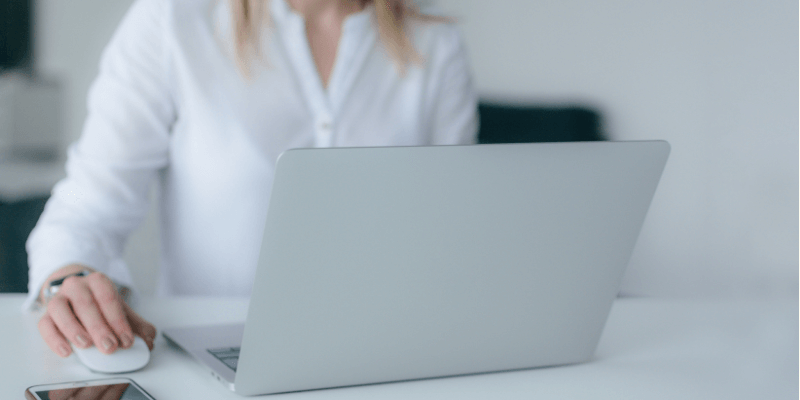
[37,0,798,296]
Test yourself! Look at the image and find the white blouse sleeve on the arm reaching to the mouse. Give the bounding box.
[24,0,176,308]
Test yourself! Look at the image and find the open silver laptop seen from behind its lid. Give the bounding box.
[164,141,669,395]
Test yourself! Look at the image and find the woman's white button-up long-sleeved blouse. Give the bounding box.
[26,0,477,307]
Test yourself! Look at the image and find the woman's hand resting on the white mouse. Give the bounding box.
[39,265,156,357]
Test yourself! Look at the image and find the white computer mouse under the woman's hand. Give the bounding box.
[73,336,150,374]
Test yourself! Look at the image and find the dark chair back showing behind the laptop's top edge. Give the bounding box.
[478,102,606,143]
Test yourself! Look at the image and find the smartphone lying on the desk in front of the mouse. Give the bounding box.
[25,378,155,400]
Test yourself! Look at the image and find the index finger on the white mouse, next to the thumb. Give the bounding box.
[86,273,133,348]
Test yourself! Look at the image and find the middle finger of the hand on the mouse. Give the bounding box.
[59,278,118,354]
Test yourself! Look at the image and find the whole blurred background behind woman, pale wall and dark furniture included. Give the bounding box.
[0,0,799,297]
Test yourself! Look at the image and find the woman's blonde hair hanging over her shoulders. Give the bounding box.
[230,0,450,77]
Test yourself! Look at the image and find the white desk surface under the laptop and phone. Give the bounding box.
[0,294,798,400]
